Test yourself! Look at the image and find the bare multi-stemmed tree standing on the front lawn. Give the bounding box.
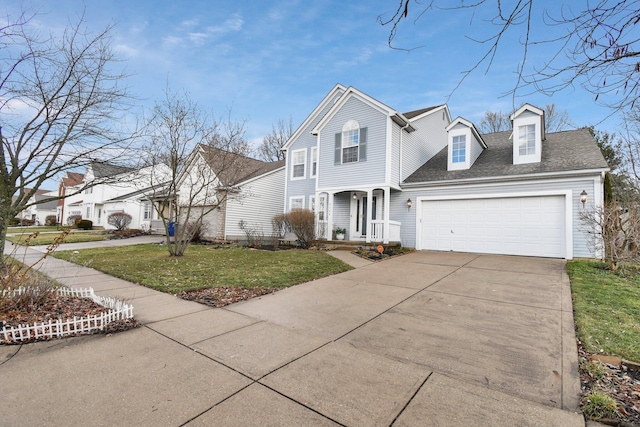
[145,90,264,256]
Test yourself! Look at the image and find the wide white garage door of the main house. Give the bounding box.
[421,196,566,258]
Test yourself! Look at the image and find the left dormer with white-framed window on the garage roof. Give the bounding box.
[446,117,487,171]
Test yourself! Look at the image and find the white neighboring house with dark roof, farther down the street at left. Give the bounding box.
[61,162,166,229]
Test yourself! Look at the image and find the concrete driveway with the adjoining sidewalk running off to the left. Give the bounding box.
[0,252,584,426]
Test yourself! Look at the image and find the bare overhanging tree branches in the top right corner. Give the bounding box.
[378,0,640,112]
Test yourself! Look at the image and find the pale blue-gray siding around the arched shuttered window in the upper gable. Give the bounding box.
[318,96,389,189]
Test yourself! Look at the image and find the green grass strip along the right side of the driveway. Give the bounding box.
[567,261,640,361]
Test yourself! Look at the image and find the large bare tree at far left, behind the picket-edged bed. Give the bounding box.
[0,10,130,263]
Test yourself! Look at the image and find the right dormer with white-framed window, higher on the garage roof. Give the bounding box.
[510,104,545,165]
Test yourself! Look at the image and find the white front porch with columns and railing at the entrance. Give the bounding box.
[311,187,402,246]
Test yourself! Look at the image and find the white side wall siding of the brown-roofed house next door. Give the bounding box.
[225,168,285,240]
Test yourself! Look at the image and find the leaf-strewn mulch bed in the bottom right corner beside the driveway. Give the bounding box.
[578,345,640,427]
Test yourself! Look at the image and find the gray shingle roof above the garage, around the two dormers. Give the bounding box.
[404,129,608,184]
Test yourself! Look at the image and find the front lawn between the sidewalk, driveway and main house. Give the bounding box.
[54,245,351,294]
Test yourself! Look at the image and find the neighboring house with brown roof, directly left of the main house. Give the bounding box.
[174,145,284,240]
